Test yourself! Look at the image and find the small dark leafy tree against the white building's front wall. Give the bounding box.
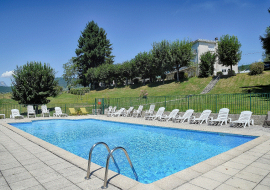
[199,51,217,77]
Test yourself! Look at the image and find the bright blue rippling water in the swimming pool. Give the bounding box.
[10,119,256,184]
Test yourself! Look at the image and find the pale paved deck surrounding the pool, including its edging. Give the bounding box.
[0,115,270,190]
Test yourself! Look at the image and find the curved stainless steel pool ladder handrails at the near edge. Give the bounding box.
[85,142,138,189]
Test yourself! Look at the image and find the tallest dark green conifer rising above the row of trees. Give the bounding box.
[74,21,114,86]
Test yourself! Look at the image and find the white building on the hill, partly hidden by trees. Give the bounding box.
[192,38,238,75]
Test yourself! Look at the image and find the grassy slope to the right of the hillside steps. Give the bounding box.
[209,71,270,94]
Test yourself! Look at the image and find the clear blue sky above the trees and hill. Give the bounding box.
[0,0,270,85]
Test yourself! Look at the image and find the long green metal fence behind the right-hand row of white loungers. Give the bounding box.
[95,93,270,115]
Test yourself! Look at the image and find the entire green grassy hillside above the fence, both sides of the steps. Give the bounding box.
[0,71,270,104]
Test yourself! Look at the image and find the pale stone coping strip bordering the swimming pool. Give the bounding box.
[1,116,270,189]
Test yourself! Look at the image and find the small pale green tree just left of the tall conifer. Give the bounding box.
[63,57,78,90]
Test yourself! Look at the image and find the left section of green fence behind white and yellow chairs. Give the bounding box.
[0,103,95,118]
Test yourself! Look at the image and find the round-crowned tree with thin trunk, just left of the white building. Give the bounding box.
[170,39,194,82]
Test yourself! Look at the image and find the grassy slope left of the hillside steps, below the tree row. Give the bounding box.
[50,77,212,103]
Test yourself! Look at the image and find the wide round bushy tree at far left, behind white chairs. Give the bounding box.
[11,62,58,104]
